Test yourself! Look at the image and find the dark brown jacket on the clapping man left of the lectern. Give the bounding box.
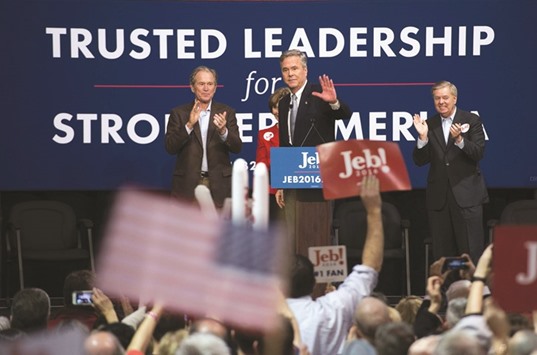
[165,101,242,207]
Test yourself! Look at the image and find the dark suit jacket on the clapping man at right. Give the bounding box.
[413,108,488,210]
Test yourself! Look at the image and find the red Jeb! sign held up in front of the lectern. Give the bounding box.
[317,140,411,200]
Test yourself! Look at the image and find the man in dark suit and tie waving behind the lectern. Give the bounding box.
[276,49,352,255]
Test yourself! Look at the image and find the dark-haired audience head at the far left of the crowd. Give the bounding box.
[11,288,50,333]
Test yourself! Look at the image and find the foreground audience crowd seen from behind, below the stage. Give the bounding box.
[0,176,537,355]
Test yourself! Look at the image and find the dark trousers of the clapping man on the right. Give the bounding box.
[428,189,485,264]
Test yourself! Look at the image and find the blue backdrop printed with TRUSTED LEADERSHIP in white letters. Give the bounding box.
[0,0,537,190]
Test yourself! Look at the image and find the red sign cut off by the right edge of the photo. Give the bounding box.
[492,227,537,313]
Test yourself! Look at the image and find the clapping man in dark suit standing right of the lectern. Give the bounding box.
[413,81,488,263]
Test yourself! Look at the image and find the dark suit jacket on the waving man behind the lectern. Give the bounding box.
[278,83,352,202]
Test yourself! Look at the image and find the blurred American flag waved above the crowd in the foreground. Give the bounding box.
[97,190,284,331]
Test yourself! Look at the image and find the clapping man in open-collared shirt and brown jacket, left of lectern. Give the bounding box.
[165,66,242,208]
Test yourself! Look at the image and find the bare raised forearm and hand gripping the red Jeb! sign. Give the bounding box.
[361,176,384,272]
